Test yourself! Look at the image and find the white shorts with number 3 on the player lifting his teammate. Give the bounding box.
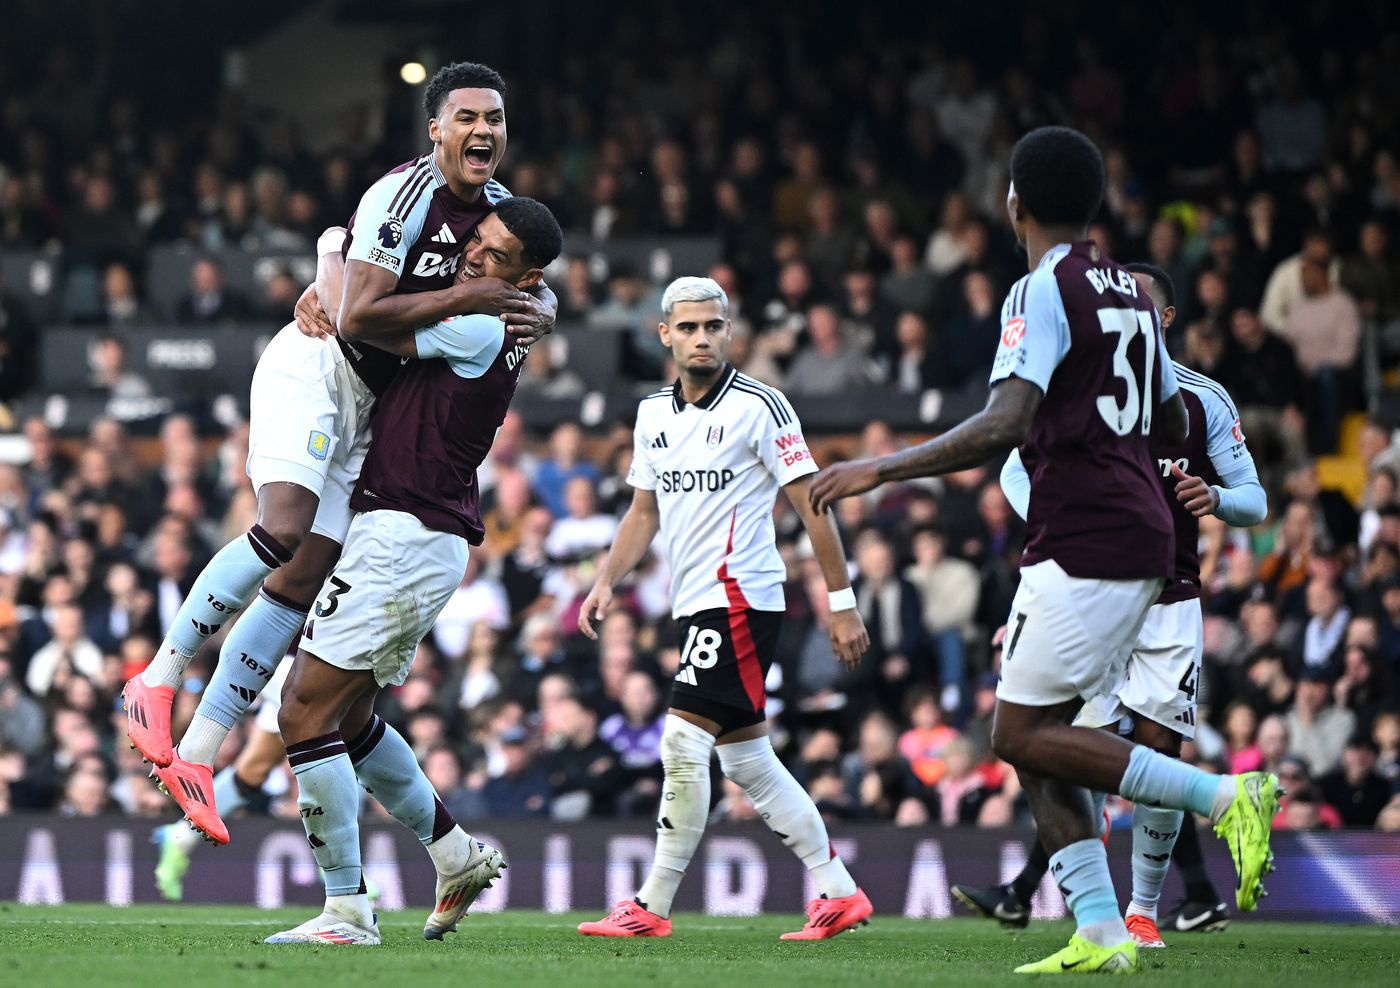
[301,511,470,686]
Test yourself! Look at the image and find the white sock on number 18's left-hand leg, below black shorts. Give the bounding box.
[637,714,714,917]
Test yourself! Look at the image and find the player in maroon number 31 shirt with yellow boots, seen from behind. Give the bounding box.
[812,127,1278,974]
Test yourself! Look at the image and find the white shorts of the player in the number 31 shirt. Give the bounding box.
[997,560,1163,707]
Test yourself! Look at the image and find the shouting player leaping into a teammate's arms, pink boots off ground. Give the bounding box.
[125,62,557,845]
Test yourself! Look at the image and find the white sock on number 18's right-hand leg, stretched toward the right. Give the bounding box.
[715,736,855,898]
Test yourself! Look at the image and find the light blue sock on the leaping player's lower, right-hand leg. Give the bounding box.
[194,589,307,727]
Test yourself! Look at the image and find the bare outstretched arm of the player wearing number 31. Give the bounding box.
[811,376,1043,511]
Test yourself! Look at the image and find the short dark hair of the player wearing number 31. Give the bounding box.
[1011,127,1105,228]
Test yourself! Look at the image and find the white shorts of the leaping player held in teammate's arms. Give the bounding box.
[248,323,374,544]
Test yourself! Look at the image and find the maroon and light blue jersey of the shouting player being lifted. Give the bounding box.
[340,151,511,396]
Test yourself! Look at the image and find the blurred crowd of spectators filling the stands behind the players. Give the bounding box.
[0,3,1400,830]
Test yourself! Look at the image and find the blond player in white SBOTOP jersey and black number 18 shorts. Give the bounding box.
[578,277,872,940]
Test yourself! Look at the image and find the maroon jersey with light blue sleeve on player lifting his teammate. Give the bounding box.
[350,315,529,546]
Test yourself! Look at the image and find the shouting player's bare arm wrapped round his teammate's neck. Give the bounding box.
[337,257,529,343]
